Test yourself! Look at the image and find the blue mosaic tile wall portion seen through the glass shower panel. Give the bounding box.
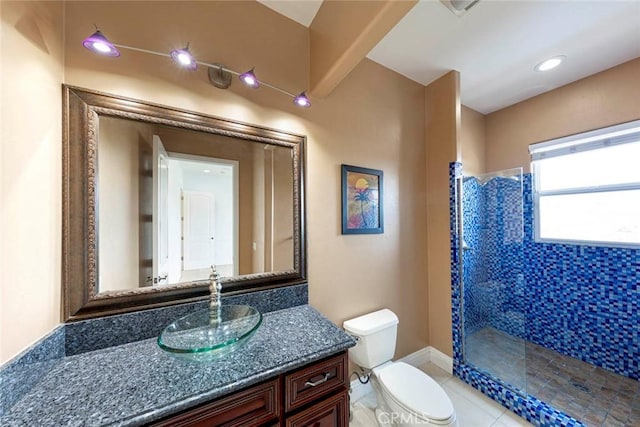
[462,175,528,338]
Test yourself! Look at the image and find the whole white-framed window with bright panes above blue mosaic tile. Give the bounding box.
[529,120,640,247]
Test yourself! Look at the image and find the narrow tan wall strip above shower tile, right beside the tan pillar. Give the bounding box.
[460,105,487,175]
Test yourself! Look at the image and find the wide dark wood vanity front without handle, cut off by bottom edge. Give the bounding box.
[153,377,280,427]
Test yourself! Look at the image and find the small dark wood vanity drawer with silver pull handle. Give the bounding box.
[284,352,348,412]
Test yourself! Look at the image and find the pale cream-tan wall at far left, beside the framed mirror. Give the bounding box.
[0,1,63,363]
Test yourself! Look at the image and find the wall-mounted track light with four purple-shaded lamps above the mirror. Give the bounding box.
[82,27,311,108]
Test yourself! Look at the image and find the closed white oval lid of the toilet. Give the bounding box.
[377,362,453,421]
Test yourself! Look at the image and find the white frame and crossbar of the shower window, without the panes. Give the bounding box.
[529,120,640,249]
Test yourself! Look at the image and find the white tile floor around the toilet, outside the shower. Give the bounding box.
[349,363,531,427]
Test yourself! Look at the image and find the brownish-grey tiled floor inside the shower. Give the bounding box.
[466,328,640,427]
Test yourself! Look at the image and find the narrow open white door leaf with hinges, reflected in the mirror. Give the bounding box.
[151,135,169,285]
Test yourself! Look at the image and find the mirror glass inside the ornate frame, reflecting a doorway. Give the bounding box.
[97,116,294,293]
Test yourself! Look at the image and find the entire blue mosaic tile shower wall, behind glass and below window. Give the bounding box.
[462,174,640,379]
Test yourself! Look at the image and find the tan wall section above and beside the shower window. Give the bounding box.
[486,58,640,172]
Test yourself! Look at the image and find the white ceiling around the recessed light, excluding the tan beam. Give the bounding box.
[259,0,640,114]
